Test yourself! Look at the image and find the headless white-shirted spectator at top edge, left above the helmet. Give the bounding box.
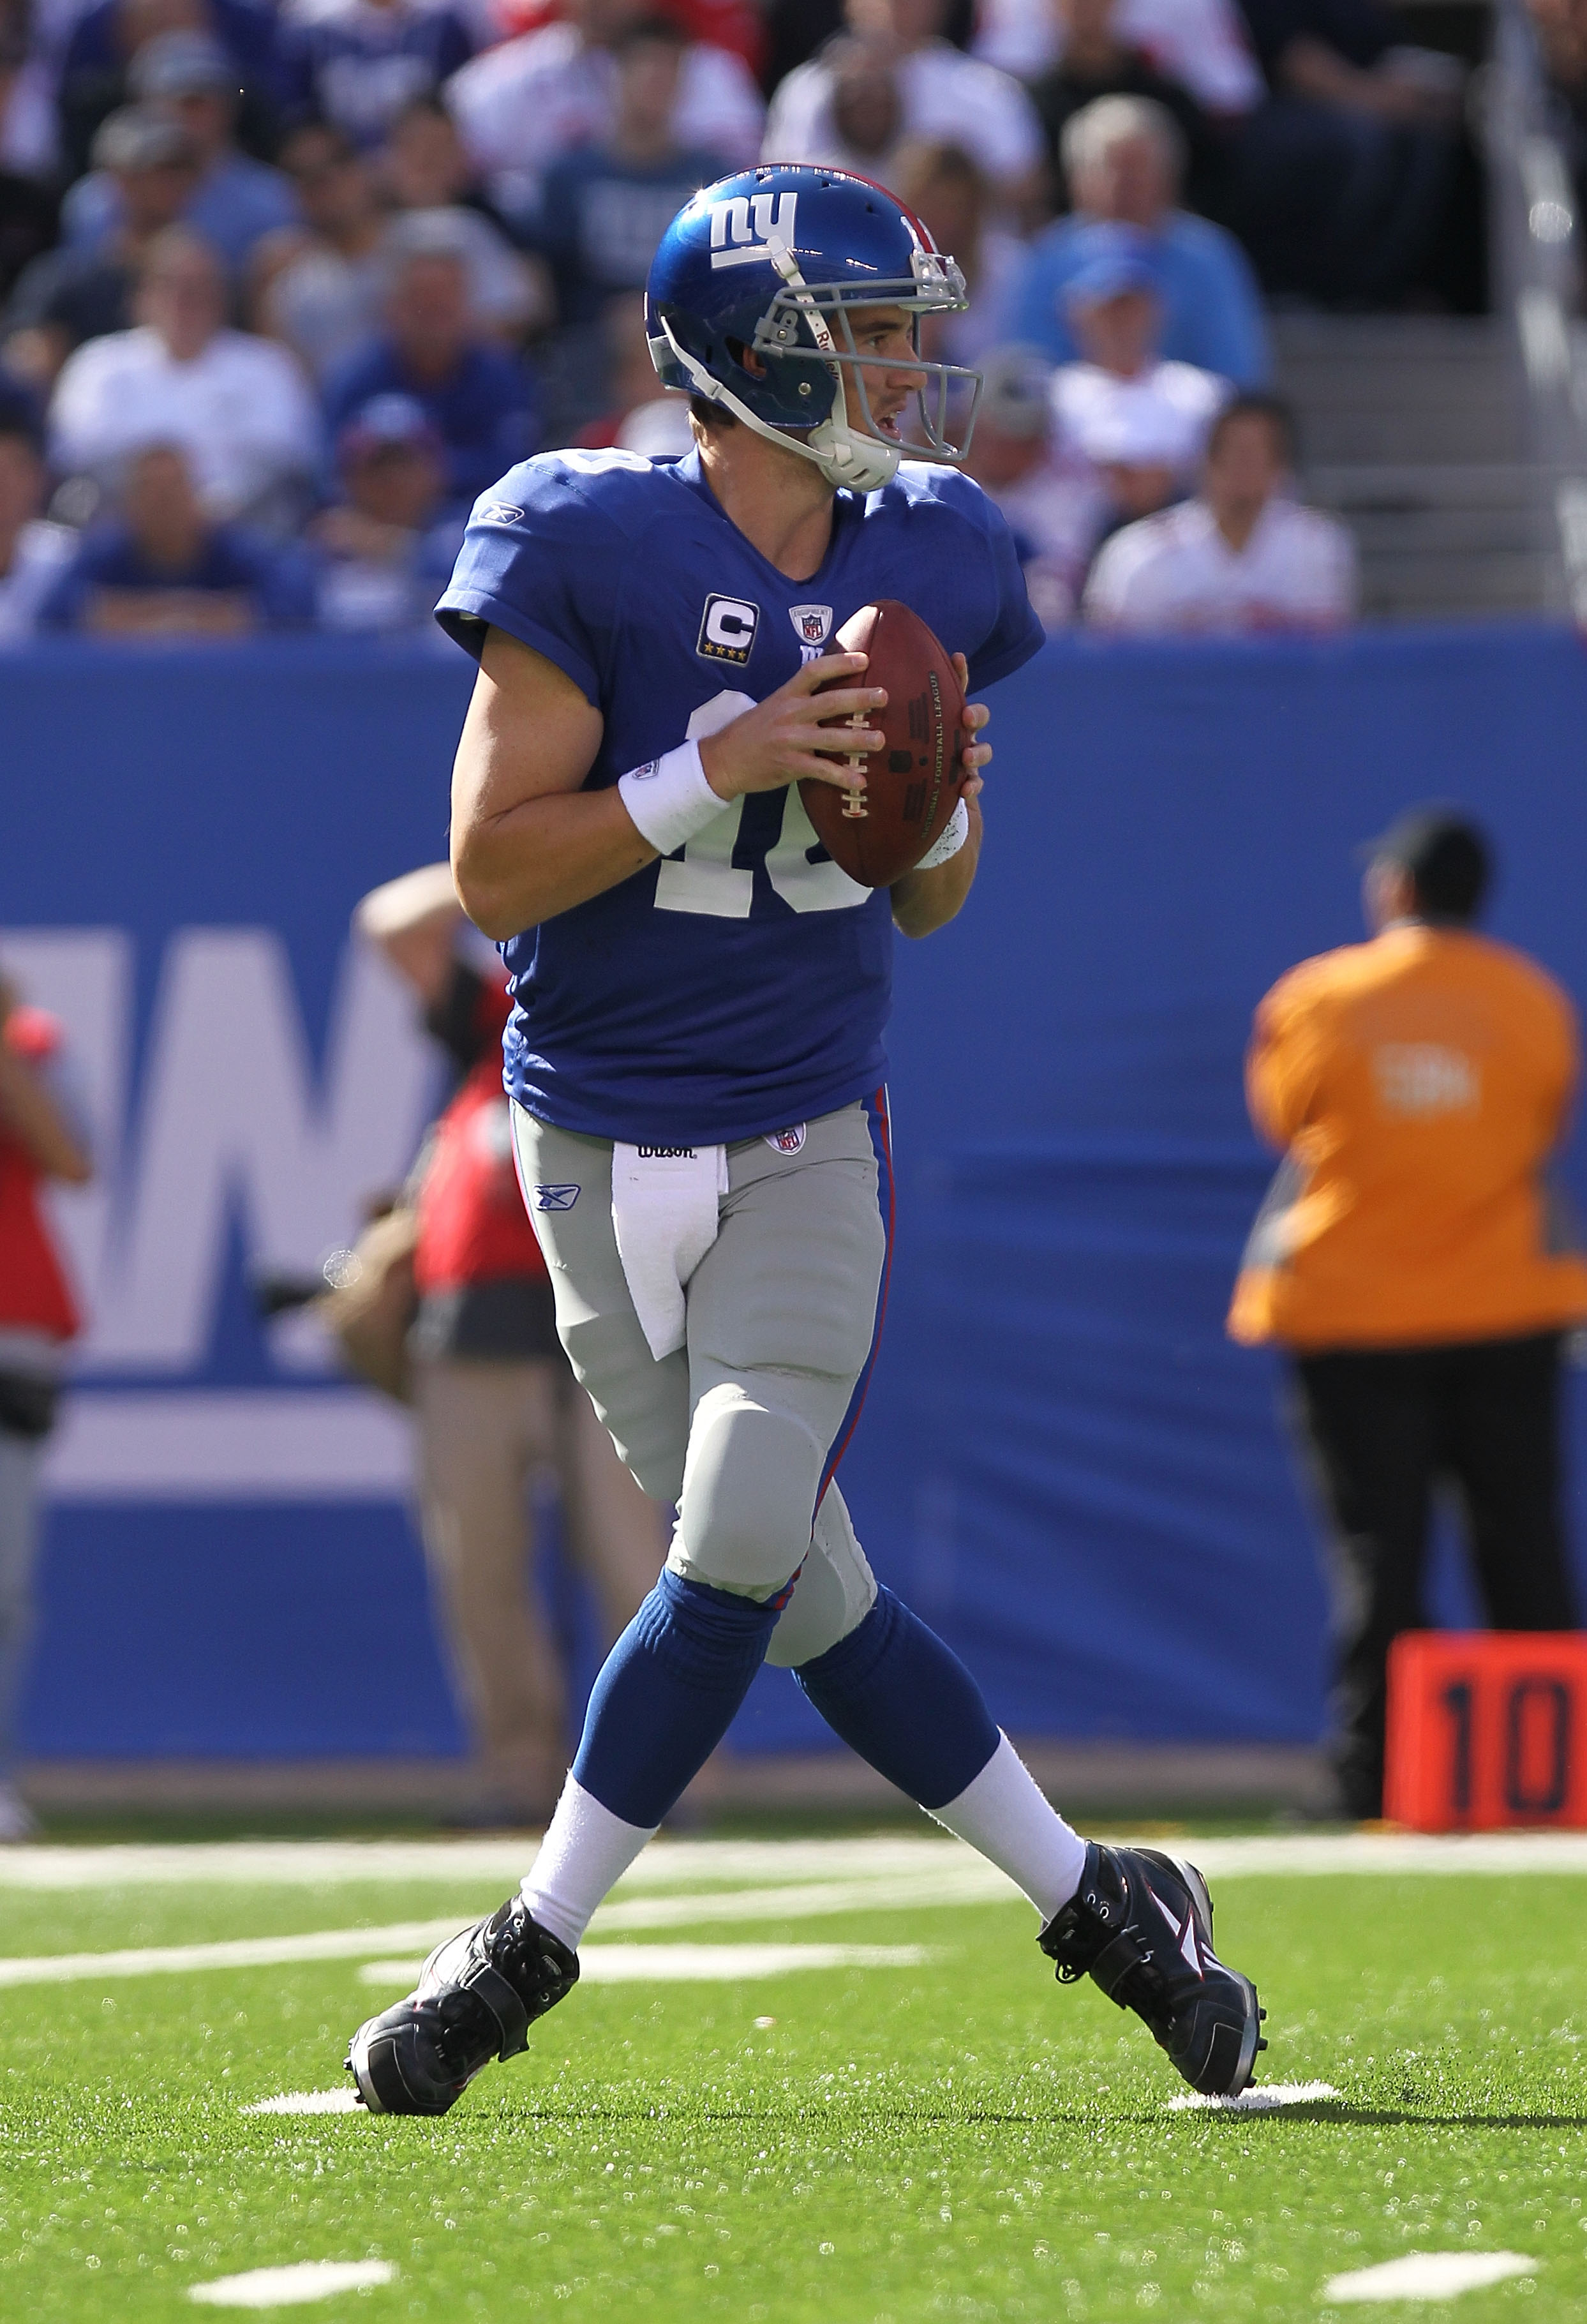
[446,0,764,228]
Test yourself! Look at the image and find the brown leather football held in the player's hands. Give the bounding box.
[800,597,964,888]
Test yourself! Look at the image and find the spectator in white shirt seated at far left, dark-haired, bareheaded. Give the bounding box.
[48,225,320,530]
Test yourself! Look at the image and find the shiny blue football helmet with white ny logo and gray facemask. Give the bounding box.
[646,163,981,493]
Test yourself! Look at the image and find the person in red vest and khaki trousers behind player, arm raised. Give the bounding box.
[355,864,667,1822]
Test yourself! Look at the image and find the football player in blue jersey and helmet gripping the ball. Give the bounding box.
[348,167,1260,2115]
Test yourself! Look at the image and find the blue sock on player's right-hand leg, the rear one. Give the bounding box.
[794,1589,1001,1808]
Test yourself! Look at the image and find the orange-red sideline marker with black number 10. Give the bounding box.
[1385,1629,1587,1831]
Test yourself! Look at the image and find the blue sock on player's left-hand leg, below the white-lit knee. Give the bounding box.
[574,1569,780,1831]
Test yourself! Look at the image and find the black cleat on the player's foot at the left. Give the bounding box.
[346,1896,579,2115]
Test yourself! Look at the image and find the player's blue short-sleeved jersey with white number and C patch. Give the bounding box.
[437,451,1041,1146]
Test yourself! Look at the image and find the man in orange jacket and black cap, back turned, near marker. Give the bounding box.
[1229,806,1587,1817]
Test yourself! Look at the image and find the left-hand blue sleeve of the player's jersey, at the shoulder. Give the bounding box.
[435,453,646,709]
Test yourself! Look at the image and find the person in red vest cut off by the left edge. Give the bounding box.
[0,978,91,1841]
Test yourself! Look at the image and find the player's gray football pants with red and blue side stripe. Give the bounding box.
[514,1104,888,1668]
